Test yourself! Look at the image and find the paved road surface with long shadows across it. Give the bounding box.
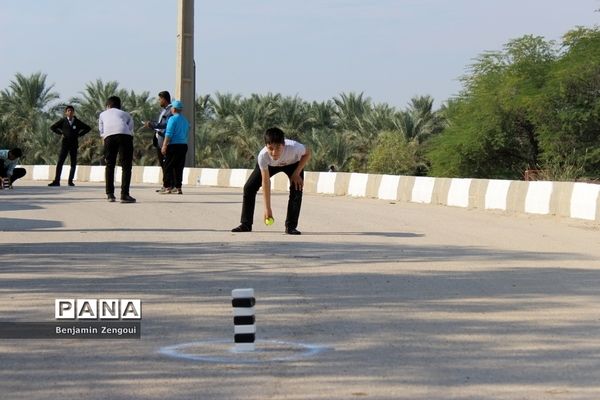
[0,181,600,400]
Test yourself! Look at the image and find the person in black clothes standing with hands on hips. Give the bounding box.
[48,106,92,186]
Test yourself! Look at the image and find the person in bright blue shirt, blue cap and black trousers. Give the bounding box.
[160,100,190,194]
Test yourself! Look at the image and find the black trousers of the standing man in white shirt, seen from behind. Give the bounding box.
[104,134,133,197]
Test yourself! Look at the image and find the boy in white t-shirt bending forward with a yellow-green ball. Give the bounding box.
[231,128,311,235]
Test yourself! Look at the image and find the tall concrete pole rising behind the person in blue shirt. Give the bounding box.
[175,0,196,167]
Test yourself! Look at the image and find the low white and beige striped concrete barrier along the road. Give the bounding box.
[22,165,600,222]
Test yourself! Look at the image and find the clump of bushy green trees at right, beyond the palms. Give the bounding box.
[427,28,600,179]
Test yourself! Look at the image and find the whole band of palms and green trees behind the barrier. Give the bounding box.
[0,27,600,180]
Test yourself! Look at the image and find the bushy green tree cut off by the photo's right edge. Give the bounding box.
[536,28,600,180]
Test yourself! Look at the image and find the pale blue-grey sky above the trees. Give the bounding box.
[0,0,600,108]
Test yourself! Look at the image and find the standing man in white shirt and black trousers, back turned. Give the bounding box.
[98,96,135,203]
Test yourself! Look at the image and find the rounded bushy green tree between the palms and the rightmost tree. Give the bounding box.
[428,36,557,178]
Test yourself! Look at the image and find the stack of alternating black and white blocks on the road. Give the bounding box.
[231,289,256,351]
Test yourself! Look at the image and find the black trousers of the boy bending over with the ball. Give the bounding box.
[240,163,304,228]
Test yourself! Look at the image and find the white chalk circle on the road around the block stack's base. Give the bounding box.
[158,339,332,364]
